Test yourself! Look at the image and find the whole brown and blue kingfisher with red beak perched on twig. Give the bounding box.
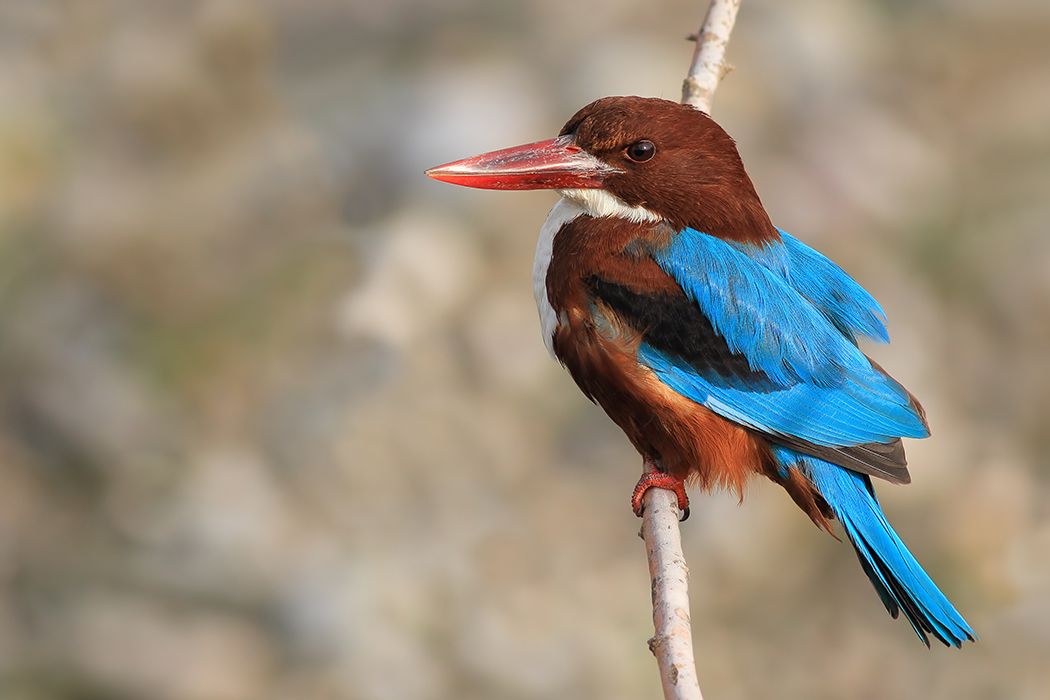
[425,97,977,648]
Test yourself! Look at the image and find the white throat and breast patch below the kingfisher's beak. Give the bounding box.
[532,189,663,359]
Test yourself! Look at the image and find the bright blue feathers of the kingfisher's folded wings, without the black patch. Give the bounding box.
[638,229,929,459]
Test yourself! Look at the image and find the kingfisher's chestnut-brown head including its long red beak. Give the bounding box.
[426,97,778,242]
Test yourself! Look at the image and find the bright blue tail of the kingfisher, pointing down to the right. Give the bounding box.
[774,446,977,646]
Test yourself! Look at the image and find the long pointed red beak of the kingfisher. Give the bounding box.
[424,136,620,190]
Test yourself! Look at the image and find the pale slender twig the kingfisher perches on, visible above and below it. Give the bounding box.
[642,0,740,700]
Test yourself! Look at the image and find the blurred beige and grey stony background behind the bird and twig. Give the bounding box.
[0,0,1050,700]
